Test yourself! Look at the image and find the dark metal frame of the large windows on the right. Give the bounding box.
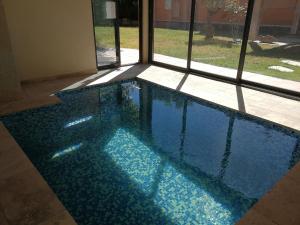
[148,0,300,100]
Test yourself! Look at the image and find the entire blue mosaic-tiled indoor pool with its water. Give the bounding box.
[1,81,300,225]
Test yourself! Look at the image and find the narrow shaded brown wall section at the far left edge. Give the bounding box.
[0,0,21,101]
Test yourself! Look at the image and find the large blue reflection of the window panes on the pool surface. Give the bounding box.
[140,81,300,199]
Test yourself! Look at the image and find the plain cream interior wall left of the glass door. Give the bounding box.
[2,0,96,81]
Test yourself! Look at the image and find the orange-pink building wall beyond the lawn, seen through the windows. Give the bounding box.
[154,0,297,27]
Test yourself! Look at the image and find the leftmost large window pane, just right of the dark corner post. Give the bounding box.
[153,0,191,68]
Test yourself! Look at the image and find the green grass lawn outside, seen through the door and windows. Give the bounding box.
[95,27,300,81]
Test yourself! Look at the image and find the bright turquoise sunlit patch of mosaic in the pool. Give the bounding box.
[104,128,233,224]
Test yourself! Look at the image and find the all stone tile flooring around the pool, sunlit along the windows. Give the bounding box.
[0,65,300,225]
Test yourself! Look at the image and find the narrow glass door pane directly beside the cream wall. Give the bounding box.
[92,0,121,68]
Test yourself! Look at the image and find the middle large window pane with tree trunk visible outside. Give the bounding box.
[191,0,248,78]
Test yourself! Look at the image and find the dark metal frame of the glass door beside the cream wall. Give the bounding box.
[90,0,143,70]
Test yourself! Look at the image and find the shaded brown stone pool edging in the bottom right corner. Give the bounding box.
[237,163,300,225]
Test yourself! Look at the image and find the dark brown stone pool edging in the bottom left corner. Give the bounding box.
[0,122,76,225]
